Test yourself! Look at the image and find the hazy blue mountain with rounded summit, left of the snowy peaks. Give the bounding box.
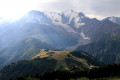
[0,11,77,48]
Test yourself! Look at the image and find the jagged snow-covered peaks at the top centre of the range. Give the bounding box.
[45,10,85,28]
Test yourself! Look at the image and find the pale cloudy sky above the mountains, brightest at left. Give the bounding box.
[0,0,120,19]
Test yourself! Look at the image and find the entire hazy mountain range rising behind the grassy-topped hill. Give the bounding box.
[0,10,120,76]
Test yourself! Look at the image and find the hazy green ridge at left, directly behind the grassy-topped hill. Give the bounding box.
[0,37,55,67]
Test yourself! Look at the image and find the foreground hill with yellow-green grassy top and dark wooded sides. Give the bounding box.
[0,49,103,80]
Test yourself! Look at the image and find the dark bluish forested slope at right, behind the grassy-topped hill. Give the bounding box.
[77,38,120,64]
